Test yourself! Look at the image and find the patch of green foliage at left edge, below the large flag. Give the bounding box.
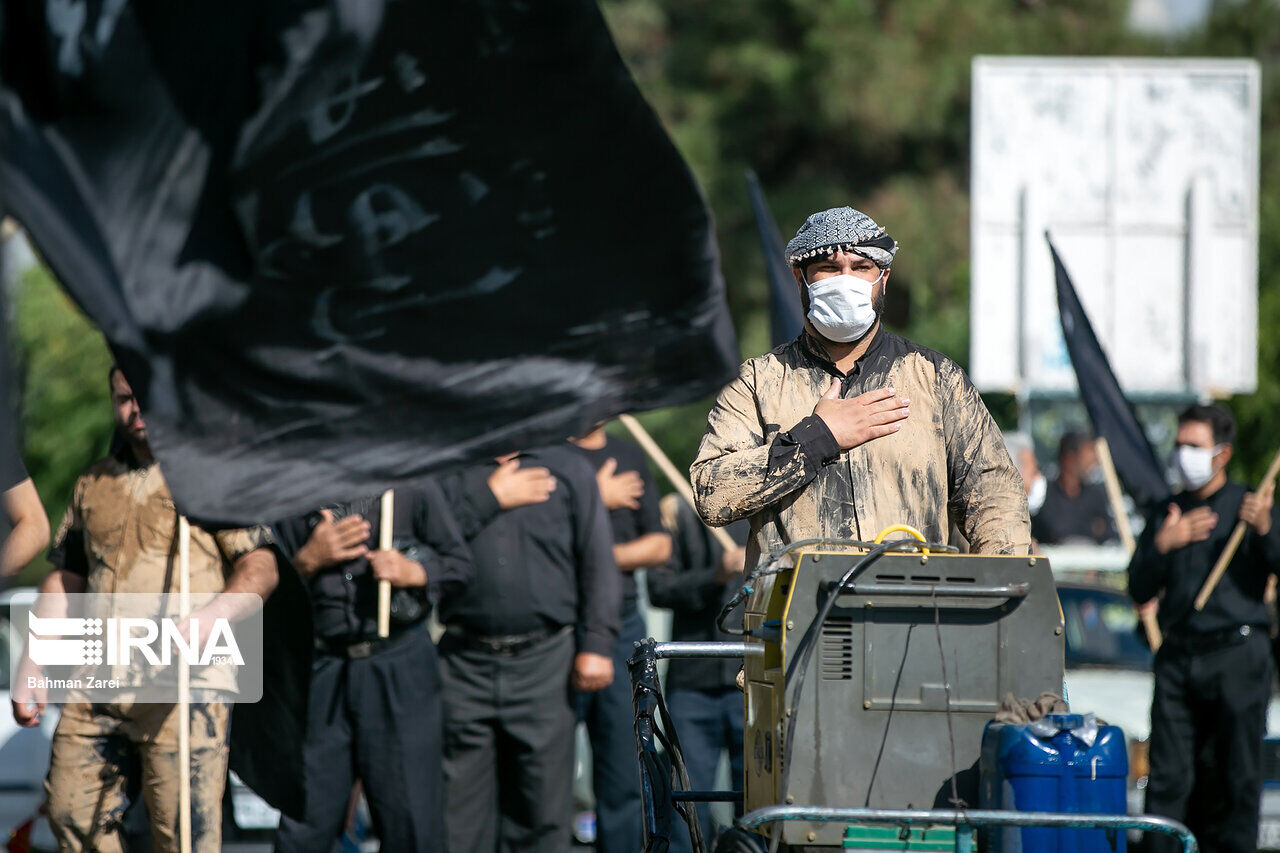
[14,266,111,581]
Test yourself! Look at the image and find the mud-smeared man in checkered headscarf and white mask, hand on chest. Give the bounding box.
[691,207,1030,566]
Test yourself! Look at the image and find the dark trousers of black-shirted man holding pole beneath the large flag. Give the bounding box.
[275,625,444,853]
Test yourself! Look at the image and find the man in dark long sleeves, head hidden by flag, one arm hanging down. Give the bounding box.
[440,447,622,853]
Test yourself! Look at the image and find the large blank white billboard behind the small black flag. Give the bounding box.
[969,56,1260,396]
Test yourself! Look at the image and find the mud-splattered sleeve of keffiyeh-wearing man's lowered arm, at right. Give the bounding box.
[938,362,1032,555]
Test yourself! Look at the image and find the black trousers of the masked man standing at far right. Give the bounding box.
[1147,630,1272,853]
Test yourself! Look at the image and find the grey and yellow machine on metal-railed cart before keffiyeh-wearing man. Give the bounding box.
[628,535,1197,853]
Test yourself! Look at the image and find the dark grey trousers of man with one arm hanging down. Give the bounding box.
[440,630,576,853]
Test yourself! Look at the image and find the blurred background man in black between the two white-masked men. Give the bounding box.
[1028,432,1116,544]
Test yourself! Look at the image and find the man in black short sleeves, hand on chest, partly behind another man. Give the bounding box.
[573,424,671,853]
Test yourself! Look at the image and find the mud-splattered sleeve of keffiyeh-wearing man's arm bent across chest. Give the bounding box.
[689,361,840,526]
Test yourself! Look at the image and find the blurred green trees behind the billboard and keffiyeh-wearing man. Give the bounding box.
[603,0,1280,479]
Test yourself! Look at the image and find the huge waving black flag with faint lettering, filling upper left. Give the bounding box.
[0,0,737,523]
